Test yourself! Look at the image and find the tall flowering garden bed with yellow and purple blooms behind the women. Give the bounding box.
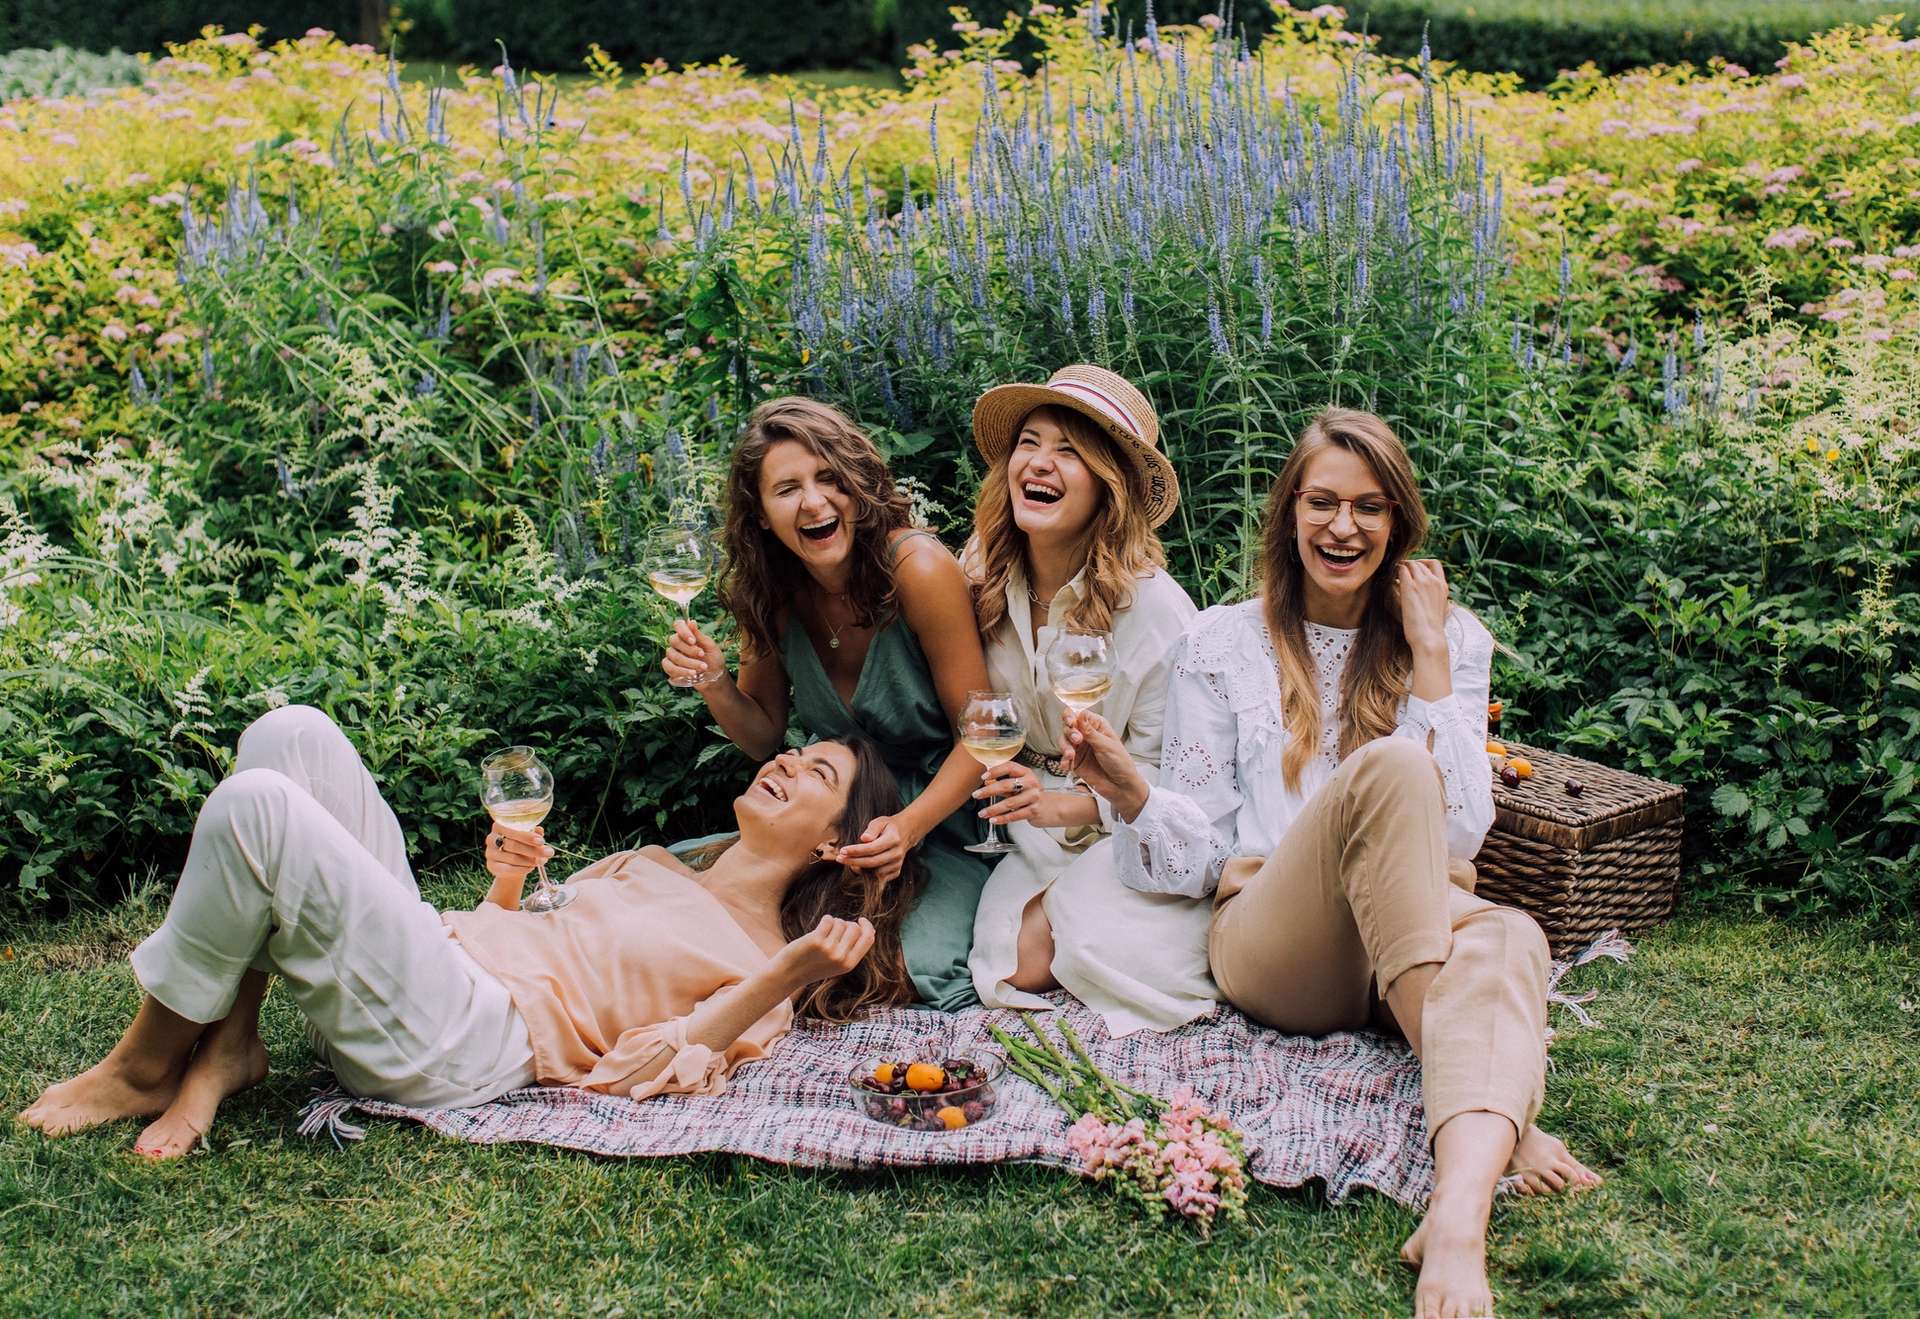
[0,13,1920,908]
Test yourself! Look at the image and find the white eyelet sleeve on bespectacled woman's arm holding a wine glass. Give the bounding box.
[1114,611,1240,899]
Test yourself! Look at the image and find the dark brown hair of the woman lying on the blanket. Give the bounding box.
[682,733,925,1021]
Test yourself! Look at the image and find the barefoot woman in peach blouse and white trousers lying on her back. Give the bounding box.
[21,707,914,1158]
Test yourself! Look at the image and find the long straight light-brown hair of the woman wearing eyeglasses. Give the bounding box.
[1261,407,1427,791]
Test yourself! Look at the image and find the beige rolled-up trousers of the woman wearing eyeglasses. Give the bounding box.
[1210,737,1548,1139]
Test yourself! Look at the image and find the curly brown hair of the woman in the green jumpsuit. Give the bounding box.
[720,397,912,655]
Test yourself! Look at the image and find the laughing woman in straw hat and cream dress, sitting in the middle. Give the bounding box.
[966,367,1215,1035]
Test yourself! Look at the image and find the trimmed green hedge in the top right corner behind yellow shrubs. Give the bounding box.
[1346,0,1920,86]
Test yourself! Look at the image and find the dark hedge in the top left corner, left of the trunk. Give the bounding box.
[0,0,361,54]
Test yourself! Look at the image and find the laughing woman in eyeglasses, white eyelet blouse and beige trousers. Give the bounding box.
[1068,409,1599,1315]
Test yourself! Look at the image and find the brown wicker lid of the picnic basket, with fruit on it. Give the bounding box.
[1494,741,1686,851]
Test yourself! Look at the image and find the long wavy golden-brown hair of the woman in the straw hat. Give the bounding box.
[973,405,1167,636]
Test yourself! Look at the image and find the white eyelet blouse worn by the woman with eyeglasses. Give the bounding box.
[1114,597,1494,897]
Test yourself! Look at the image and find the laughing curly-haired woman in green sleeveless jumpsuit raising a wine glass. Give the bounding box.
[660,397,987,1012]
